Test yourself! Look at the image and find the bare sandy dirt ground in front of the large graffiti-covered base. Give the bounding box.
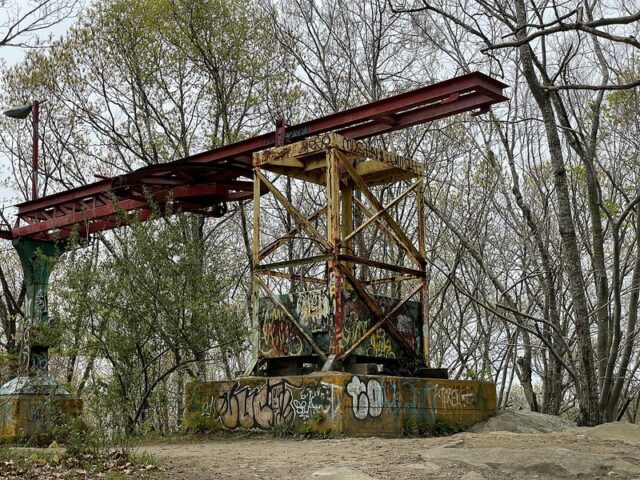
[143,419,640,480]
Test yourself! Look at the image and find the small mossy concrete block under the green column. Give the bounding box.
[0,395,82,440]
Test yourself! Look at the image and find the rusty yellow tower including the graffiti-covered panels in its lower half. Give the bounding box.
[247,133,429,376]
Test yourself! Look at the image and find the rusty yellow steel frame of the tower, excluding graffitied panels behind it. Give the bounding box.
[247,134,429,373]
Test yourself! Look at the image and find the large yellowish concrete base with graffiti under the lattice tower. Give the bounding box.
[184,372,496,436]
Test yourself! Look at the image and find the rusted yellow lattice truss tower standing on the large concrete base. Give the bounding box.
[246,133,429,374]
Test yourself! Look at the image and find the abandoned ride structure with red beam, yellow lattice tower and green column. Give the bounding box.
[0,72,506,436]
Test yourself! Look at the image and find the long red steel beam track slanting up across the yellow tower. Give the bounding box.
[0,72,507,240]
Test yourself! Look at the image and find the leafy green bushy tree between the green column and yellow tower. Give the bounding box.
[53,205,247,432]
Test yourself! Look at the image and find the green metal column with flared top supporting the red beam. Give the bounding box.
[13,238,64,376]
